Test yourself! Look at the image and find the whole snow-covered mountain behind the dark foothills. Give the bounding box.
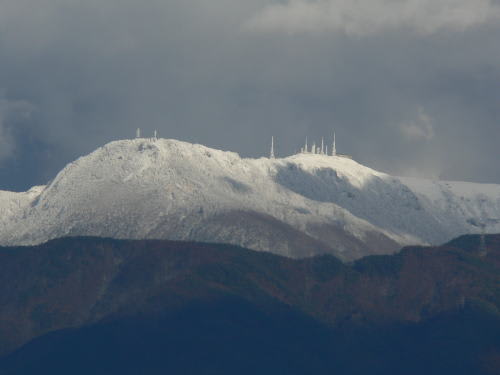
[0,139,500,259]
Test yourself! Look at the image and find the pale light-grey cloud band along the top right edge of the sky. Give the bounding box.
[245,0,500,36]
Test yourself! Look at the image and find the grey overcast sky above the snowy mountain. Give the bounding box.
[0,0,500,190]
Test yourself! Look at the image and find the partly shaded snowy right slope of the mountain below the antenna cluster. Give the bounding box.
[277,154,500,244]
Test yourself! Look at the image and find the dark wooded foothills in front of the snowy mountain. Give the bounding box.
[0,235,500,375]
